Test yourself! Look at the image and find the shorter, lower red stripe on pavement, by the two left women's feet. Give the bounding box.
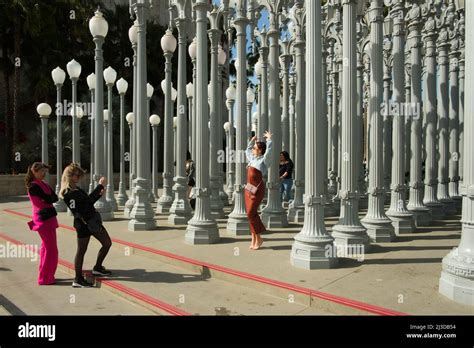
[0,233,192,316]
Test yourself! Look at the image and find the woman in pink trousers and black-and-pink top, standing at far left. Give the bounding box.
[25,162,59,285]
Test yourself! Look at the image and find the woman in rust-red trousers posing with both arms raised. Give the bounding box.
[245,132,272,250]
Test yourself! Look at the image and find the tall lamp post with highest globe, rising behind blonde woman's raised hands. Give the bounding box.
[89,10,114,221]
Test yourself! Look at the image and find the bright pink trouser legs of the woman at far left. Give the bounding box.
[38,229,58,285]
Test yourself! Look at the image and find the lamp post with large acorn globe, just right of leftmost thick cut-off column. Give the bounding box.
[156,29,178,214]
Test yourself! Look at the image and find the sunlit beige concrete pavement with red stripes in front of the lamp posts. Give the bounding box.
[0,197,474,315]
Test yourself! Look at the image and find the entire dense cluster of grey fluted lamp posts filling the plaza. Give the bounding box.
[38,0,474,303]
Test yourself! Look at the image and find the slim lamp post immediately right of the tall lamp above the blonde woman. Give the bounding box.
[104,66,118,211]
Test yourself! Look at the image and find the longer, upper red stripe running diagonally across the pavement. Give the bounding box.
[4,209,409,316]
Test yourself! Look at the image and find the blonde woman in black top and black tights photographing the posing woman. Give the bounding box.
[59,163,112,288]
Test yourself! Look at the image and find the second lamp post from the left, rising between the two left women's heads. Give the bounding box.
[51,67,67,212]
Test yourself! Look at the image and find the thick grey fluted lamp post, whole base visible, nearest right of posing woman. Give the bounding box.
[290,1,338,269]
